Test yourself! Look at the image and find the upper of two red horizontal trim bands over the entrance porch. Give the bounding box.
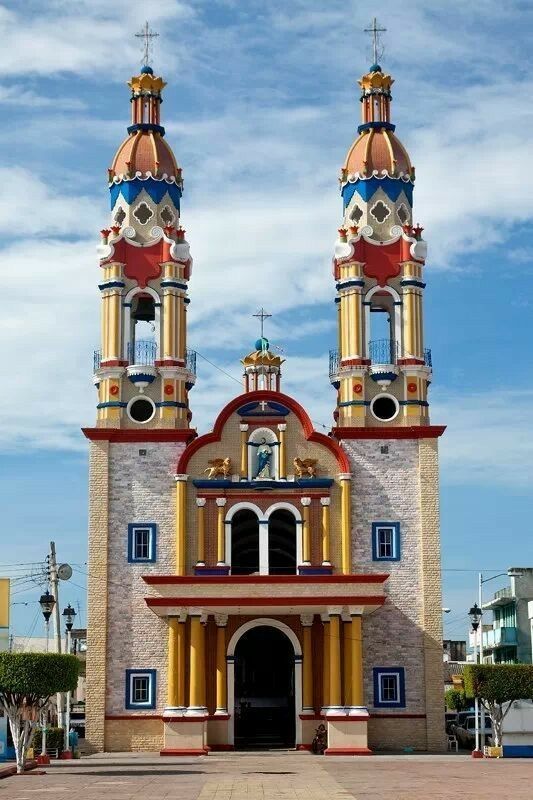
[143,572,389,586]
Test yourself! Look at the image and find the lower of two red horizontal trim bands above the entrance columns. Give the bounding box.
[144,594,386,608]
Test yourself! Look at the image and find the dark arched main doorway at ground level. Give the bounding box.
[235,625,296,750]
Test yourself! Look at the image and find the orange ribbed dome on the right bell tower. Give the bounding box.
[343,128,412,176]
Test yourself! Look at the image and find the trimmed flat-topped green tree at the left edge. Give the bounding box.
[0,653,80,773]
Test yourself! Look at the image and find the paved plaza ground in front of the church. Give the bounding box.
[0,752,533,800]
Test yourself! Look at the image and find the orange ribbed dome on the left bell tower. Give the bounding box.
[111,130,179,177]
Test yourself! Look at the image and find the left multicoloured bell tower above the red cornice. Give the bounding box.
[94,54,196,429]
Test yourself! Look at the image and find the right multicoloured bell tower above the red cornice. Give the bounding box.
[330,52,431,428]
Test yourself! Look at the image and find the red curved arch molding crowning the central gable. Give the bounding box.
[177,390,350,475]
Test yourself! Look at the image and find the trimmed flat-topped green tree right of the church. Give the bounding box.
[464,664,533,747]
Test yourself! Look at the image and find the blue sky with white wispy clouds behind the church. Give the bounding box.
[0,0,533,637]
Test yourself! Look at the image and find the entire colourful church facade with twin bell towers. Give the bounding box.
[84,53,444,755]
